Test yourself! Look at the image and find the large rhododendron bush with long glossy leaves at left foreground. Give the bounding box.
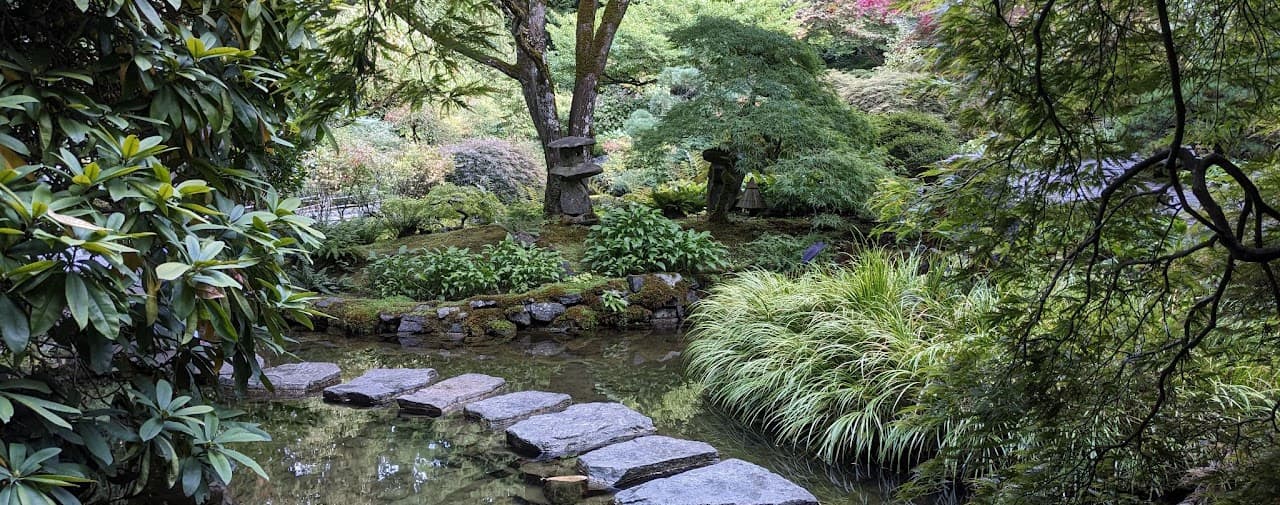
[0,0,335,504]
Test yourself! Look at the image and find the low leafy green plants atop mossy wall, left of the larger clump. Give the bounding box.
[366,247,497,300]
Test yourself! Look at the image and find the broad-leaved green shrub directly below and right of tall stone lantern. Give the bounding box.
[582,205,728,275]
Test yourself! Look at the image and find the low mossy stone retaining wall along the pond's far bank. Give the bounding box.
[315,274,699,346]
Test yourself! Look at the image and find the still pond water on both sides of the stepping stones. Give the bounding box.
[222,332,890,505]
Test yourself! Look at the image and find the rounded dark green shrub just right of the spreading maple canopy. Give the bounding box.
[874,113,960,176]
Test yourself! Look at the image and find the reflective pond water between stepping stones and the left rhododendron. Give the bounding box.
[233,400,522,505]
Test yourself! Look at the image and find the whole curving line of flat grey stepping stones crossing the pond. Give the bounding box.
[263,363,818,505]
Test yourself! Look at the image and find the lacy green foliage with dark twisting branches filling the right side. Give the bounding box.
[875,0,1280,502]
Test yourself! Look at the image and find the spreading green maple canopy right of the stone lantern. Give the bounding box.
[637,18,886,219]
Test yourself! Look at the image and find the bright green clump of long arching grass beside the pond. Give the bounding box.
[687,251,995,465]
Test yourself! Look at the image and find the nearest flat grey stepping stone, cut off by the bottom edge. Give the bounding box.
[613,459,818,505]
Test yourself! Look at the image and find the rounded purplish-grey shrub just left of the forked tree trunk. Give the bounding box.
[440,138,543,203]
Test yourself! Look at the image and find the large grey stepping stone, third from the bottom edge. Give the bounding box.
[507,403,654,459]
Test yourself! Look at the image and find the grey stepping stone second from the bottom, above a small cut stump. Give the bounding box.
[577,436,719,490]
